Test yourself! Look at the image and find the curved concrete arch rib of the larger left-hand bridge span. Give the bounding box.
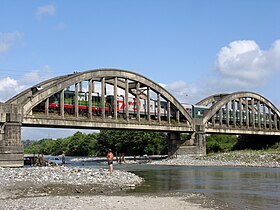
[18,69,193,125]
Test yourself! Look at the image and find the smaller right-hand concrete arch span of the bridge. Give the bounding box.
[194,92,280,135]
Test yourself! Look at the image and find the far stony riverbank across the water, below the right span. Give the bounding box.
[71,150,280,168]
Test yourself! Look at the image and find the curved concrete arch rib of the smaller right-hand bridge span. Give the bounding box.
[202,92,280,125]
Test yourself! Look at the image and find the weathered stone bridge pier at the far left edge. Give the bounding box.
[0,103,24,167]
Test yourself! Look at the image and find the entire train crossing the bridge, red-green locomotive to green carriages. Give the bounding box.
[33,90,276,126]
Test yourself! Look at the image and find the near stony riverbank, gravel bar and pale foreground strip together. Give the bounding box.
[0,166,221,210]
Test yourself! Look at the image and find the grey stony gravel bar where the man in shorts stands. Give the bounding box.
[0,166,143,199]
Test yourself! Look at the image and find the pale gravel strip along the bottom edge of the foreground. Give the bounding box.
[0,195,208,210]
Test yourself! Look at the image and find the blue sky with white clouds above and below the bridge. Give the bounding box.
[0,0,280,139]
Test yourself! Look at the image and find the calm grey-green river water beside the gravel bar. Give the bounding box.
[68,160,280,209]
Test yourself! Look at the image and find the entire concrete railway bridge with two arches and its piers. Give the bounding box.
[0,69,280,167]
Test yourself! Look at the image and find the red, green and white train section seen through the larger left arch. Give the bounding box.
[33,90,175,118]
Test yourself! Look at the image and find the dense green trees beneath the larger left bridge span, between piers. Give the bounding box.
[25,130,167,156]
